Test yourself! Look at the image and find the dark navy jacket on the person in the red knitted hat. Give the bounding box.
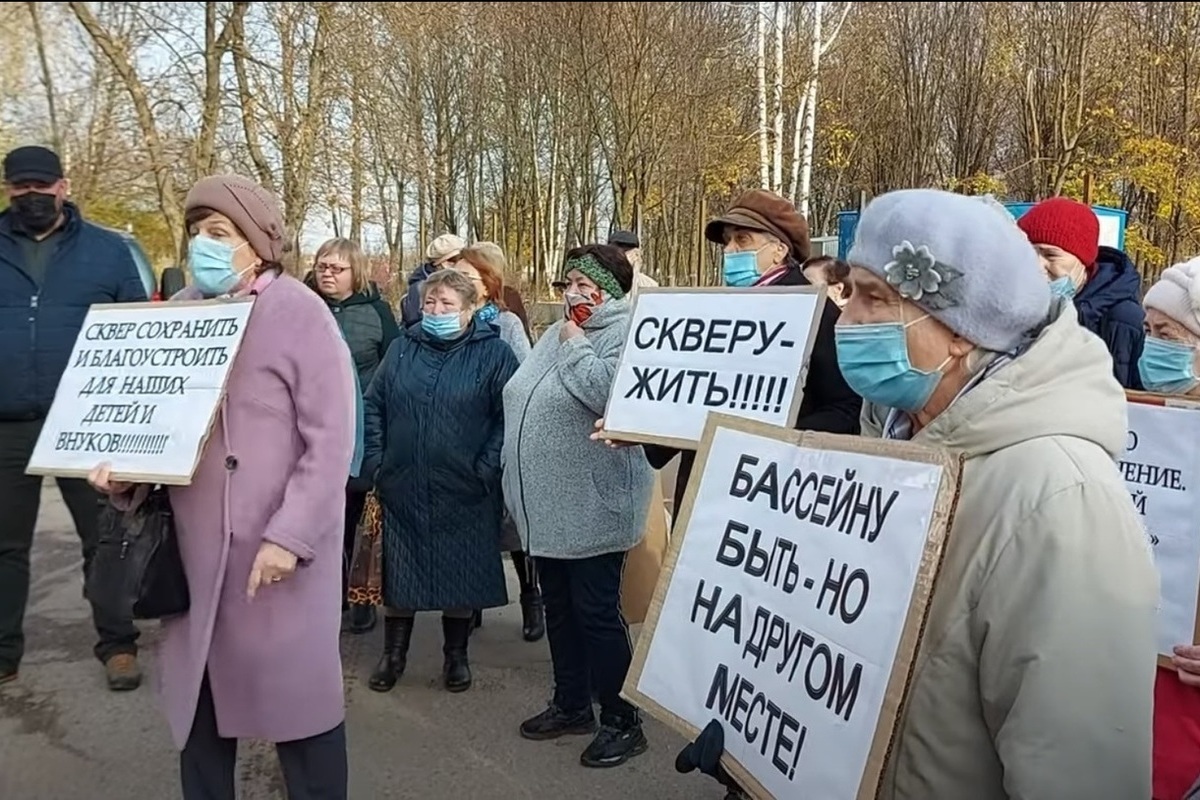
[1075,247,1146,389]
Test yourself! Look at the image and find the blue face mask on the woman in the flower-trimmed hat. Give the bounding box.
[834,317,950,413]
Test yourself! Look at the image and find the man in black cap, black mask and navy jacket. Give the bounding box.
[0,148,146,691]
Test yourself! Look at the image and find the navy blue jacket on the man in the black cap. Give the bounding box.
[0,203,146,421]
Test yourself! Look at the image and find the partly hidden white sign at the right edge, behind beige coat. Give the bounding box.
[1118,401,1200,656]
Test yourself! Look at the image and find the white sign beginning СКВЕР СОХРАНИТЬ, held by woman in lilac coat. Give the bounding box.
[26,297,253,485]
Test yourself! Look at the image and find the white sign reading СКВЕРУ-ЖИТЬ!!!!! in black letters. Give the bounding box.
[605,287,826,449]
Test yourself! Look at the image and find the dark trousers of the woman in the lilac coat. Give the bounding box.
[179,674,349,800]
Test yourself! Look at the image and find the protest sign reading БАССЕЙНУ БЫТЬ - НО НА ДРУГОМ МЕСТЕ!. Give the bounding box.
[624,414,960,800]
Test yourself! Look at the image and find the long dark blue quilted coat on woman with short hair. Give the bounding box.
[362,323,517,610]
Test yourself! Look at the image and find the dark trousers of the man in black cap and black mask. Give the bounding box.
[0,420,138,672]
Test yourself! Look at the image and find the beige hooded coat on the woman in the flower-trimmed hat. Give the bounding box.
[880,305,1158,800]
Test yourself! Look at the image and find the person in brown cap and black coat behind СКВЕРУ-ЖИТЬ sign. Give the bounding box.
[644,190,863,518]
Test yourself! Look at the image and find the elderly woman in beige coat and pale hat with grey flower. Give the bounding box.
[681,190,1158,800]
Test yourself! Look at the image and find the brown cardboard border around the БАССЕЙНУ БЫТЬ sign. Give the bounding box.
[622,413,962,800]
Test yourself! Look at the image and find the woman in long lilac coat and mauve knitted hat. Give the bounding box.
[90,175,355,800]
